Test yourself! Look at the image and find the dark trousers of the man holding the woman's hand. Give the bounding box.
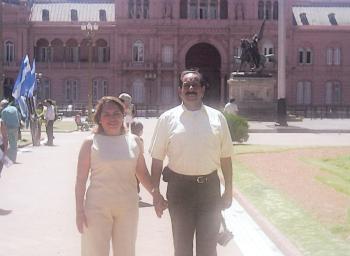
[167,172,221,256]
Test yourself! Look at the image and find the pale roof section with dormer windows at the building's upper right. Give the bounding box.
[293,5,350,26]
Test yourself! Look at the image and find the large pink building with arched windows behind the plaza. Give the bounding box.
[2,0,350,113]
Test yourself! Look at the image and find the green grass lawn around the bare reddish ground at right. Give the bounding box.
[234,145,350,256]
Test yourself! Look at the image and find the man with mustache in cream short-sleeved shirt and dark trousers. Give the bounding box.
[150,70,232,256]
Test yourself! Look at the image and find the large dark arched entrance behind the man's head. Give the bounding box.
[185,43,221,105]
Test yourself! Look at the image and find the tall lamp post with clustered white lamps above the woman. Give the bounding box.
[80,22,98,122]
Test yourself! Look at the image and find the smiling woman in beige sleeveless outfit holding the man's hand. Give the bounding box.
[75,96,163,256]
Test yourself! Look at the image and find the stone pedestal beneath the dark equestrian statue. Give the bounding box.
[227,72,277,116]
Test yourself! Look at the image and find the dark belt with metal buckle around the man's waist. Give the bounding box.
[163,167,217,184]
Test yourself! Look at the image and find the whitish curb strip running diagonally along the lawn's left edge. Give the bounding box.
[234,189,303,256]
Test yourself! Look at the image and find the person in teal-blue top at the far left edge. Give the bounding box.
[0,99,20,163]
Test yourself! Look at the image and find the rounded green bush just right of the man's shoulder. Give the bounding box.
[224,113,249,143]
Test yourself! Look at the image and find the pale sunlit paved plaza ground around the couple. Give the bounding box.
[0,119,350,256]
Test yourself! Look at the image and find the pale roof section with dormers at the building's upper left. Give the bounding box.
[30,0,115,22]
